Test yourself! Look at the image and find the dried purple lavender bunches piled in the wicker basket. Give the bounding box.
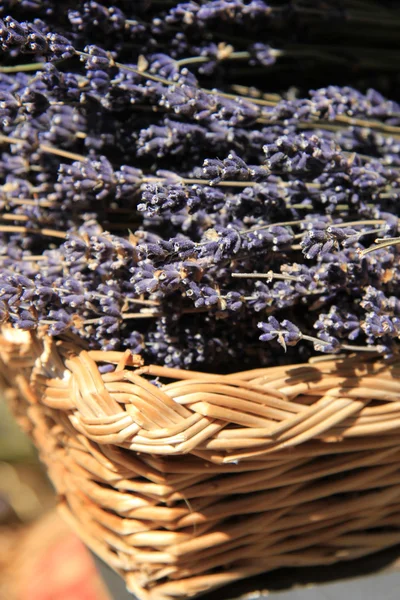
[0,0,400,372]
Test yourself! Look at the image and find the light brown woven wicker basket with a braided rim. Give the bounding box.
[0,328,400,600]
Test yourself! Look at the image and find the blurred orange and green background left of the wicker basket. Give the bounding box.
[0,399,111,600]
